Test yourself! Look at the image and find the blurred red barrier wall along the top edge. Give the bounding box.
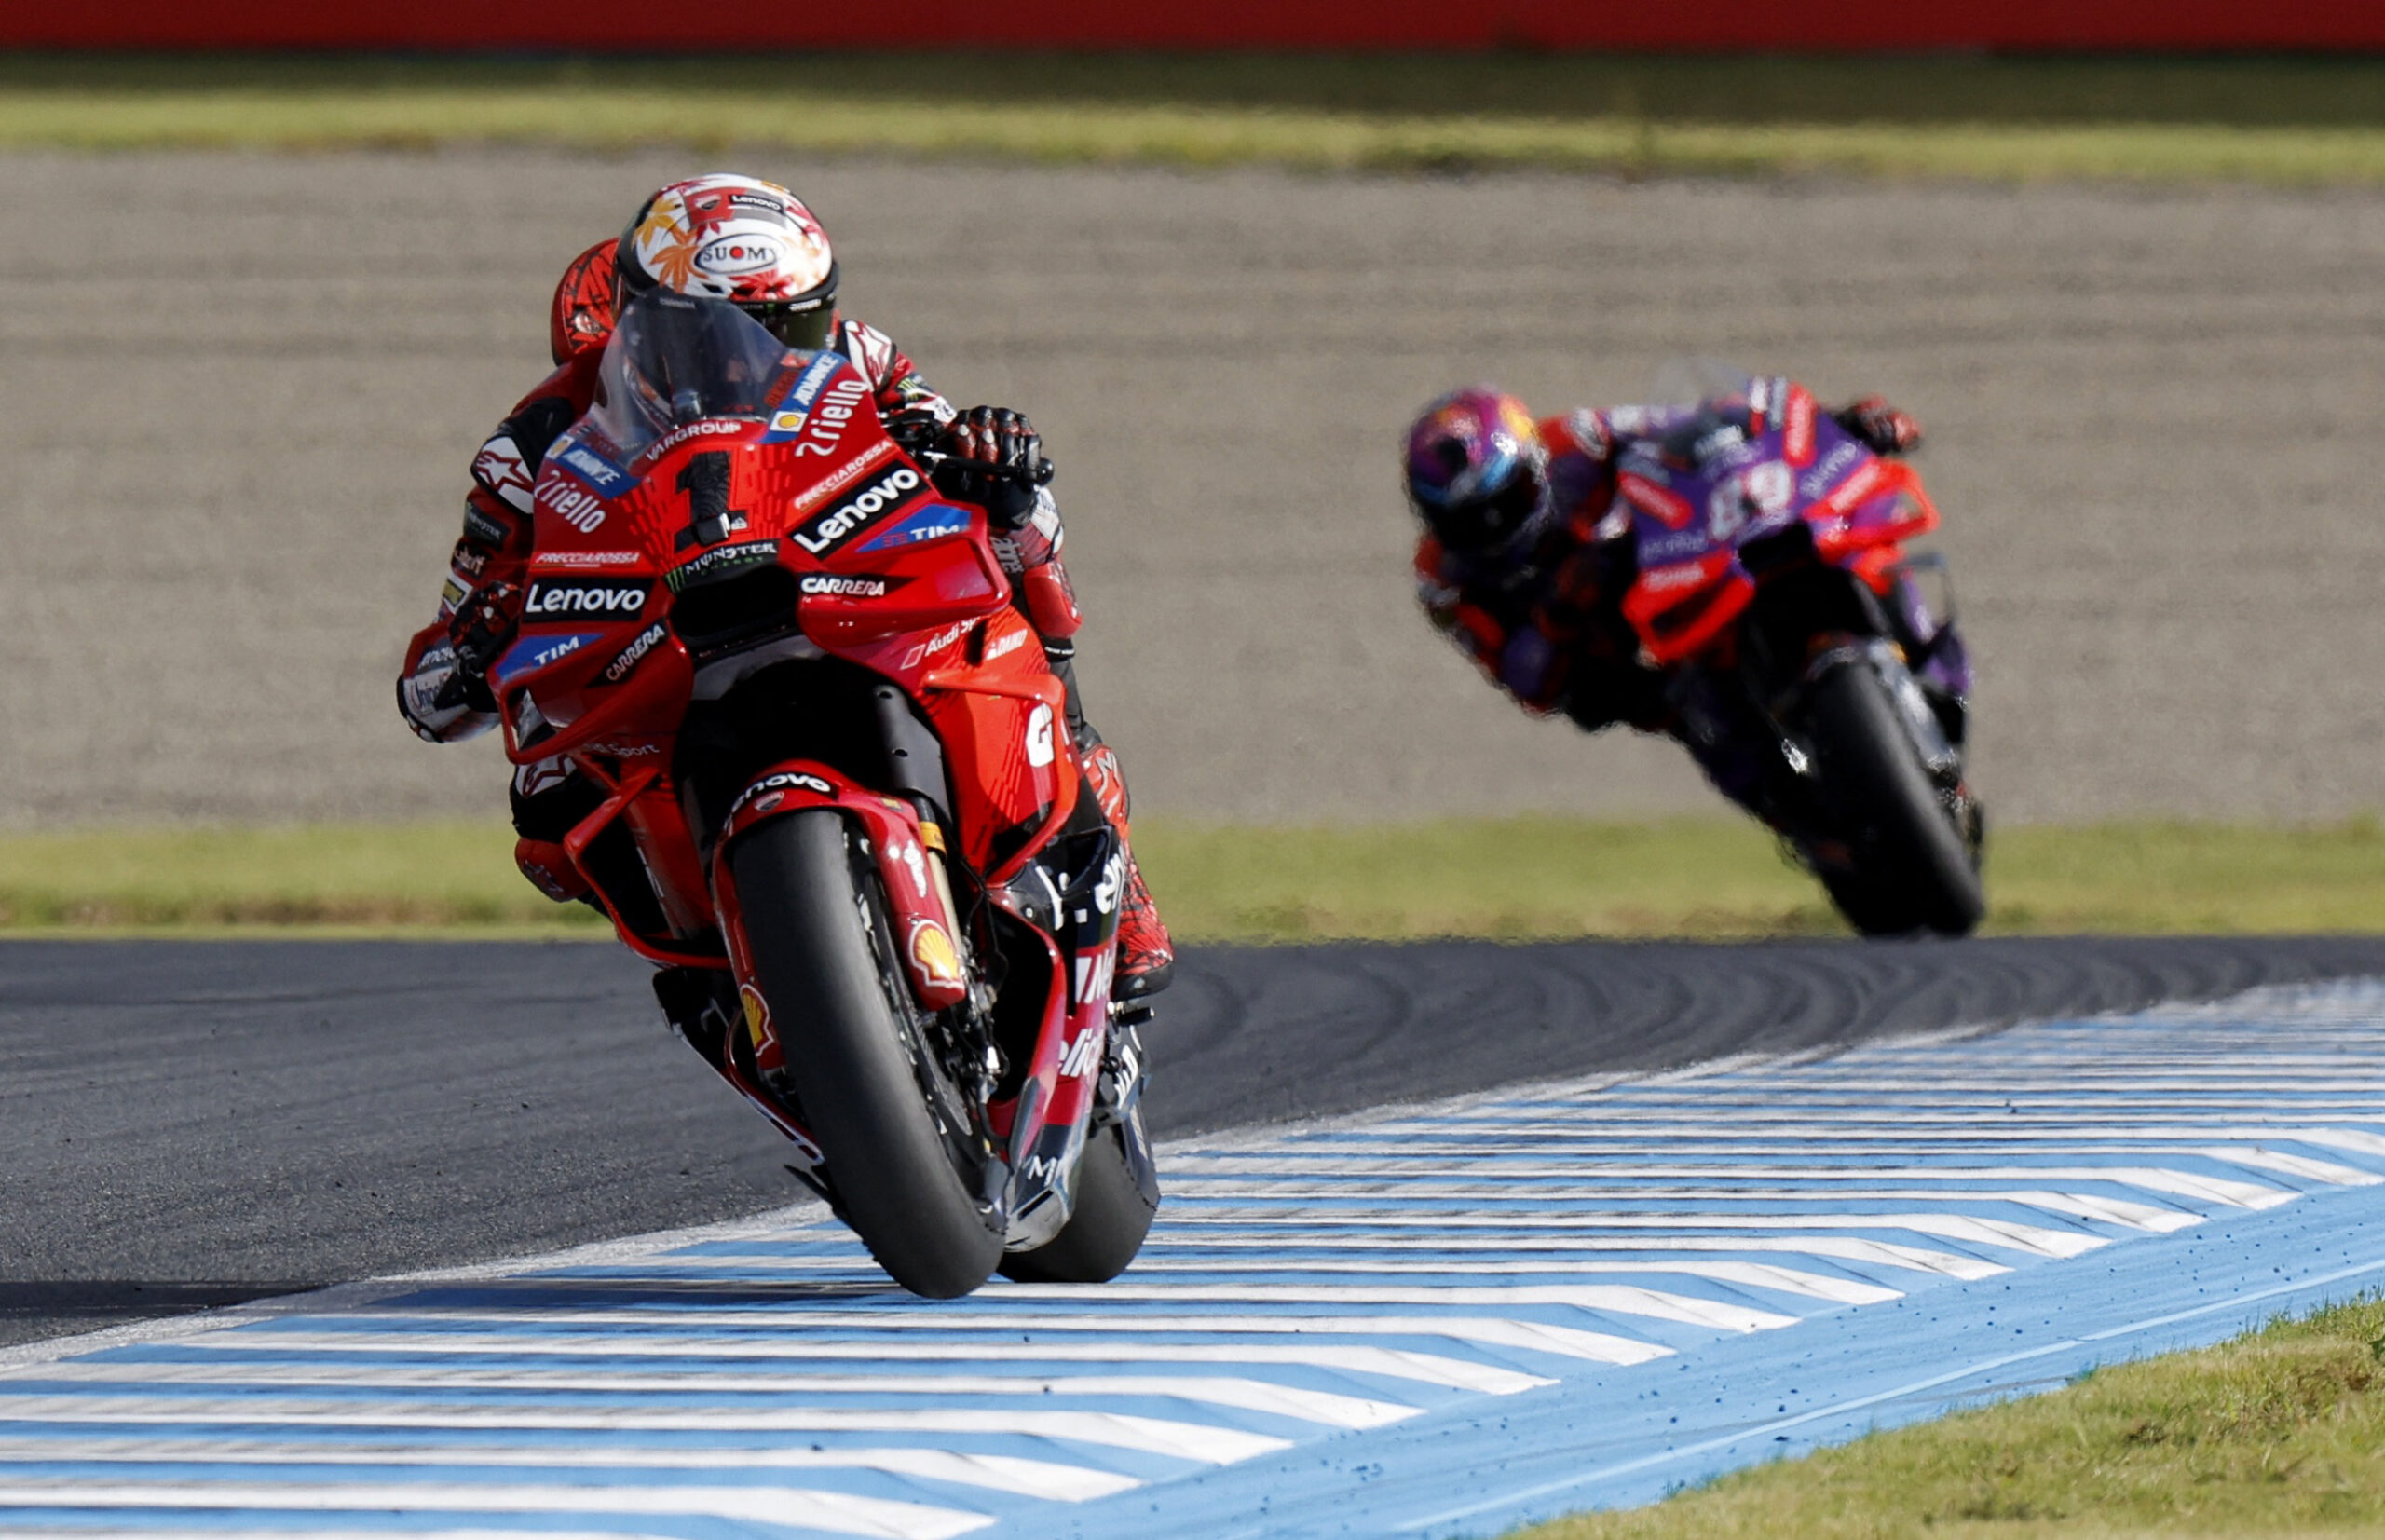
[0,0,2385,50]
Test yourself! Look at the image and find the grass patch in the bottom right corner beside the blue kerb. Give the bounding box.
[1517,1300,2385,1540]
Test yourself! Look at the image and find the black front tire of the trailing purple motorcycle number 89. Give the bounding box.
[1806,662,1986,937]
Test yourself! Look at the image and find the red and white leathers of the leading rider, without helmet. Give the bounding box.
[399,240,1174,999]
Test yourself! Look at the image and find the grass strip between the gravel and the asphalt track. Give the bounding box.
[0,818,2385,942]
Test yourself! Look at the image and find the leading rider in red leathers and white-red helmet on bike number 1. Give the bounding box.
[399,174,1174,1002]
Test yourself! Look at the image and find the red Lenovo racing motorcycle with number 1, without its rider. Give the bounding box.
[486,293,1159,1297]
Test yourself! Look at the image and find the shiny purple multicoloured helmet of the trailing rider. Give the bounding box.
[1407,387,1555,555]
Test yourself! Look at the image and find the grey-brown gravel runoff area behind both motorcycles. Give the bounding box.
[0,153,2385,823]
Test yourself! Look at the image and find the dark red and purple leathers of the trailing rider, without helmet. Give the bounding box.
[1417,396,1922,827]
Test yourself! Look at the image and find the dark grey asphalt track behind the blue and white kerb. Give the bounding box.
[14,939,2385,1342]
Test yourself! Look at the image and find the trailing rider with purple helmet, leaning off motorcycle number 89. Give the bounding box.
[1405,381,1922,829]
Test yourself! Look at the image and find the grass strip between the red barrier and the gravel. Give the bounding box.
[14,52,2385,184]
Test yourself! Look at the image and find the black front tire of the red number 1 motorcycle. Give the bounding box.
[729,811,1002,1300]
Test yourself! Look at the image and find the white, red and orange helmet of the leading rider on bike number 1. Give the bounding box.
[613,176,838,350]
